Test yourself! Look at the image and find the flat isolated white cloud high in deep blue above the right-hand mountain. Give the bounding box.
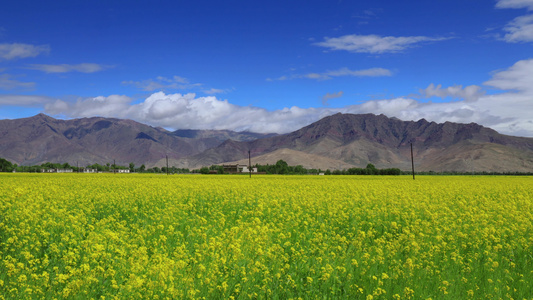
[315,34,449,54]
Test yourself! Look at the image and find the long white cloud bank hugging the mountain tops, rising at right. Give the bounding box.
[42,59,533,137]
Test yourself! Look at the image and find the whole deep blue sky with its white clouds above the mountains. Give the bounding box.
[0,0,533,136]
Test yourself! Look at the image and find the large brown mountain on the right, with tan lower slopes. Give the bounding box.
[176,114,533,172]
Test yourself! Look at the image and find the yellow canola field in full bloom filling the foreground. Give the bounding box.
[0,174,533,299]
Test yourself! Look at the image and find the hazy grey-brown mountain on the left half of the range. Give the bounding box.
[0,114,270,166]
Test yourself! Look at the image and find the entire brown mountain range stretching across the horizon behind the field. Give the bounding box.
[0,113,533,172]
